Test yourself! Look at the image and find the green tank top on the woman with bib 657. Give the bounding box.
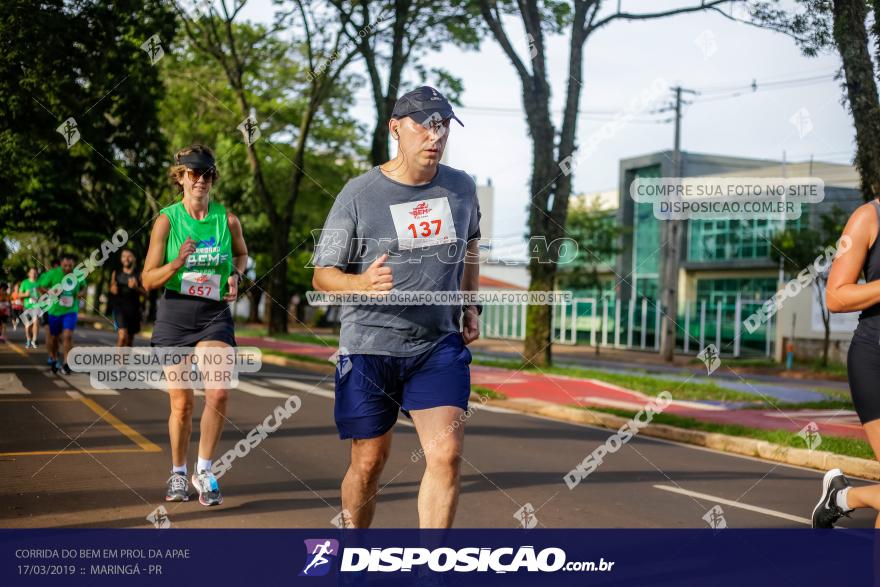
[161,200,232,300]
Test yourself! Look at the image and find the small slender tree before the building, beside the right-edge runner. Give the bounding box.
[770,206,847,367]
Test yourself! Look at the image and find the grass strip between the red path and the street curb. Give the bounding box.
[575,406,874,460]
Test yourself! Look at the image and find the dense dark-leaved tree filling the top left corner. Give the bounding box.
[0,0,175,316]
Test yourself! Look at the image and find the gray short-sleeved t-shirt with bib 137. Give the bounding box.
[312,165,480,357]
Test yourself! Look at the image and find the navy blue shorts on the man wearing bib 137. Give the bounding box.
[333,332,471,439]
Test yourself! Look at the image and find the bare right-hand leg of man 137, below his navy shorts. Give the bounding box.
[412,406,464,528]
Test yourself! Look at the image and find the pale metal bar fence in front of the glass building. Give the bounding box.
[481,295,774,357]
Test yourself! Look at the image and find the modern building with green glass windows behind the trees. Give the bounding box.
[603,151,864,355]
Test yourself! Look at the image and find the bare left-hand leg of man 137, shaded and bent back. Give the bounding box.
[342,429,394,528]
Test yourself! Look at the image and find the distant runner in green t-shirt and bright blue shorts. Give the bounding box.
[37,256,84,375]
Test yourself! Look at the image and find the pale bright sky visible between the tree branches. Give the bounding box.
[235,0,854,248]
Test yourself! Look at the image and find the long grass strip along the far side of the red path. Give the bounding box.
[473,358,763,405]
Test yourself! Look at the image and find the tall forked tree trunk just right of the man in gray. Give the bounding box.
[479,0,736,365]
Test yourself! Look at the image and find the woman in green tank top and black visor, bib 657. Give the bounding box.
[141,145,247,506]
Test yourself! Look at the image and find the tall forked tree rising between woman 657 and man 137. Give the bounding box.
[180,0,366,334]
